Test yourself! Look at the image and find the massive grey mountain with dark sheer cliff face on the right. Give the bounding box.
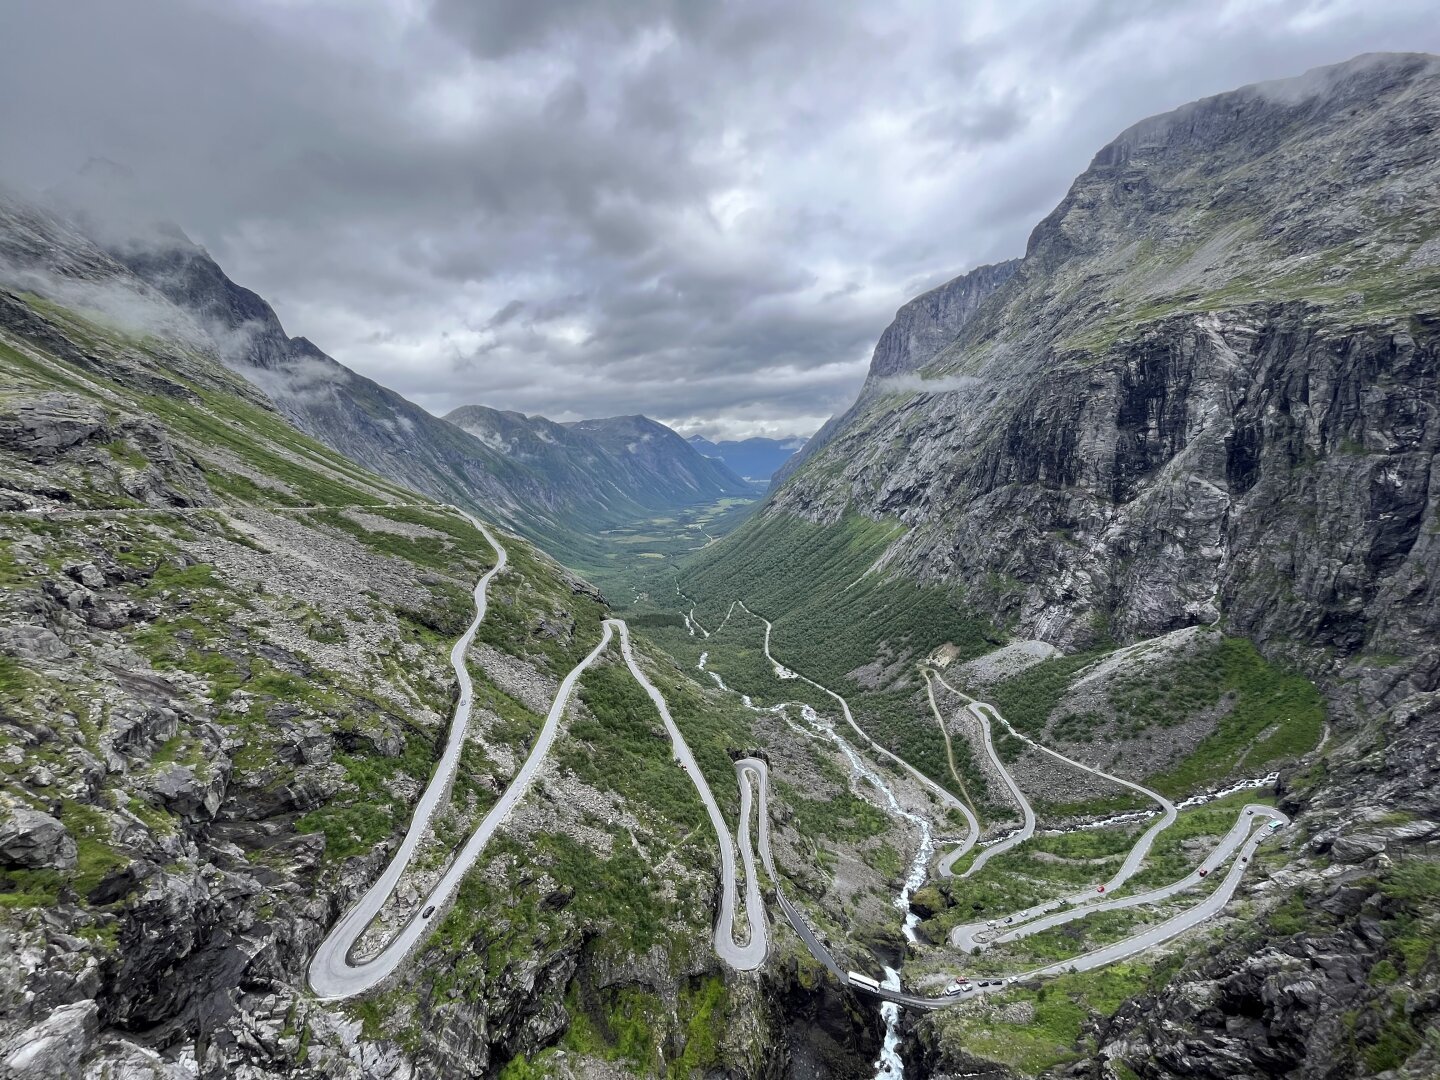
[770,58,1440,690]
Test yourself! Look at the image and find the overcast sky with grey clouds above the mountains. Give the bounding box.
[0,0,1440,436]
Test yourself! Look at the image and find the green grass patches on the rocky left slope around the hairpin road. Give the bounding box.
[0,292,766,1070]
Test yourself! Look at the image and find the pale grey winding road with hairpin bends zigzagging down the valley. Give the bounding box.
[310,514,1289,1009]
